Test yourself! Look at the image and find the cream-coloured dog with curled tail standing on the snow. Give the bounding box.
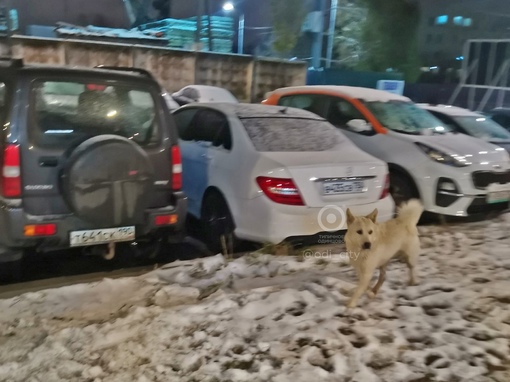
[345,199,423,308]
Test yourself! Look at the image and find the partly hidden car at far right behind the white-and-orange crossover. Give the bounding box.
[418,104,510,152]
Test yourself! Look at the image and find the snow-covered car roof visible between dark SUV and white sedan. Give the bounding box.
[167,85,239,111]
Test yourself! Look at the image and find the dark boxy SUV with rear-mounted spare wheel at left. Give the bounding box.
[0,60,186,280]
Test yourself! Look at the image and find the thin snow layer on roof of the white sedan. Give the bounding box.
[183,102,325,121]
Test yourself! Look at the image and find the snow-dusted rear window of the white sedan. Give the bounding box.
[241,117,343,152]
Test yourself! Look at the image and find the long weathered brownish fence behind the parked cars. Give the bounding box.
[8,36,307,102]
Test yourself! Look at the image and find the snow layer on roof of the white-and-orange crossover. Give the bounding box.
[274,85,411,102]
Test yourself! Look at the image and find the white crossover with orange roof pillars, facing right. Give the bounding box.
[263,86,510,216]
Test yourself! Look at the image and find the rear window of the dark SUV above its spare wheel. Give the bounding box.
[30,81,159,147]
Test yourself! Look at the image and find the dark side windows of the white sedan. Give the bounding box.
[181,109,232,150]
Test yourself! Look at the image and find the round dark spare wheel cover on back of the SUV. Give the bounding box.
[62,135,154,228]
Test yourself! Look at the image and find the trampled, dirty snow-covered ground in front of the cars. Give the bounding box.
[0,215,510,382]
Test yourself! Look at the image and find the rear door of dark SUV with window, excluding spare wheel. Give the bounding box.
[19,71,175,219]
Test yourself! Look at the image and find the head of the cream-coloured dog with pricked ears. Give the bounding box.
[345,209,378,251]
